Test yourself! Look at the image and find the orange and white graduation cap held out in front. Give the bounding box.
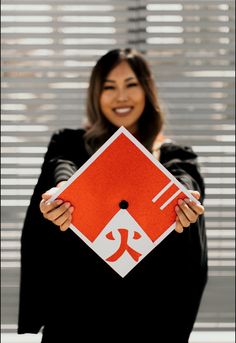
[50,127,197,277]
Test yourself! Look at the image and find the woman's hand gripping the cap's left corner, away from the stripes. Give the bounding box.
[39,183,74,231]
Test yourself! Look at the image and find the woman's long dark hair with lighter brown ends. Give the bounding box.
[84,48,164,154]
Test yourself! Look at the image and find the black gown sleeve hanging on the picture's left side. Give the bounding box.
[18,131,77,334]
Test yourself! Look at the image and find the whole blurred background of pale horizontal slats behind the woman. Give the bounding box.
[1,0,235,343]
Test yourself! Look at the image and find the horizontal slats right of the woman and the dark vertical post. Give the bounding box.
[141,1,235,331]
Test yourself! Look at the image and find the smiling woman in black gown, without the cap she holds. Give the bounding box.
[18,49,207,343]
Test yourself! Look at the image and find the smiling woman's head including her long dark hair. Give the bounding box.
[85,49,164,153]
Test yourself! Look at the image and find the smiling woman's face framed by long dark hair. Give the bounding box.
[100,61,145,133]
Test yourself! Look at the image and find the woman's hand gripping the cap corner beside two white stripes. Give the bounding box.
[175,191,204,233]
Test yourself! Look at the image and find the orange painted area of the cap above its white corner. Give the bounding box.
[59,133,186,242]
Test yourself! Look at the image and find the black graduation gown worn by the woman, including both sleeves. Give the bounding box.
[18,129,207,343]
